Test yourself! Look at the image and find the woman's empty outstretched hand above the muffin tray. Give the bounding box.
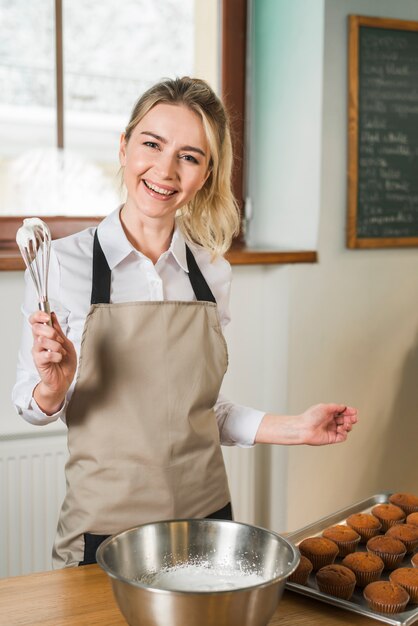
[300,404,357,446]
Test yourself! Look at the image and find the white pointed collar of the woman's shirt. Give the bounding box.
[97,207,189,272]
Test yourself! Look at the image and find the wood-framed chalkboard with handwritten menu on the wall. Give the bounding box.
[347,15,418,248]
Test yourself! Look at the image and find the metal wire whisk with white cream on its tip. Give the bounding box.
[16,217,52,325]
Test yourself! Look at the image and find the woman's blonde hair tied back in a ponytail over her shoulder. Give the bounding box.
[125,76,240,257]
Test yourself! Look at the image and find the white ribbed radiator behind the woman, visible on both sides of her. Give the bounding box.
[0,434,255,577]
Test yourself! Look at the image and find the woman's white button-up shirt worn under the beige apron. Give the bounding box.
[13,209,264,447]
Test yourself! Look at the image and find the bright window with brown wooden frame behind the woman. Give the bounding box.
[0,0,247,269]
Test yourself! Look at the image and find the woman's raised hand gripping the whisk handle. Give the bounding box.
[29,311,77,415]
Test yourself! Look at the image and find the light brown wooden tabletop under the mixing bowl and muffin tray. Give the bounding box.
[0,565,378,626]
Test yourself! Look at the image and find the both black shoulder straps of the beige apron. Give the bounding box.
[91,228,216,304]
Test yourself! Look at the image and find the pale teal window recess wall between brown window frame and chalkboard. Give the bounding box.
[248,0,324,249]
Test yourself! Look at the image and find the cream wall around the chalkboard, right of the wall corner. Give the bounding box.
[287,0,418,529]
